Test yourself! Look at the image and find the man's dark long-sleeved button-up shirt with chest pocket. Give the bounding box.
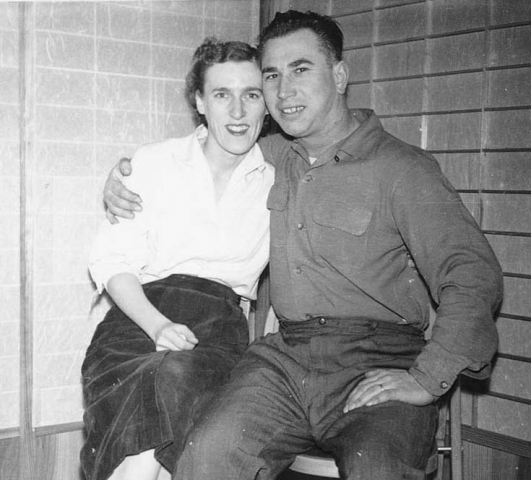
[260,110,502,395]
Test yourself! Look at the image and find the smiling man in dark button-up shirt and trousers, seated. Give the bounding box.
[105,11,502,480]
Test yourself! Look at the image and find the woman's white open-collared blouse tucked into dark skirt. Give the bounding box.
[89,126,274,299]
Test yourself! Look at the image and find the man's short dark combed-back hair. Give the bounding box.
[258,10,343,62]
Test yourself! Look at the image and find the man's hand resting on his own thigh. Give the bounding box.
[343,369,435,413]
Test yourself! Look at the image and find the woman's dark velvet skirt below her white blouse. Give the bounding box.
[81,275,249,480]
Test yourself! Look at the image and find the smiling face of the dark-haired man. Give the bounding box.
[262,29,346,139]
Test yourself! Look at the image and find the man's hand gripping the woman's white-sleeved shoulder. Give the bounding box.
[103,158,142,224]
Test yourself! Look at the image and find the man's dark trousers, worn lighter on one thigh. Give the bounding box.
[174,318,437,480]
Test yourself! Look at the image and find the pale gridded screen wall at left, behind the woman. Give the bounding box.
[0,0,259,480]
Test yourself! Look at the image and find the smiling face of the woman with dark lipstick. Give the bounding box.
[196,61,266,158]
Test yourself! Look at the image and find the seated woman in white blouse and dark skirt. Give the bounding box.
[81,39,274,480]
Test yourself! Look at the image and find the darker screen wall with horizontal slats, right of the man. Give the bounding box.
[273,0,531,480]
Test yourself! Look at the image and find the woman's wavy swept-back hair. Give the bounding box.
[186,37,260,125]
